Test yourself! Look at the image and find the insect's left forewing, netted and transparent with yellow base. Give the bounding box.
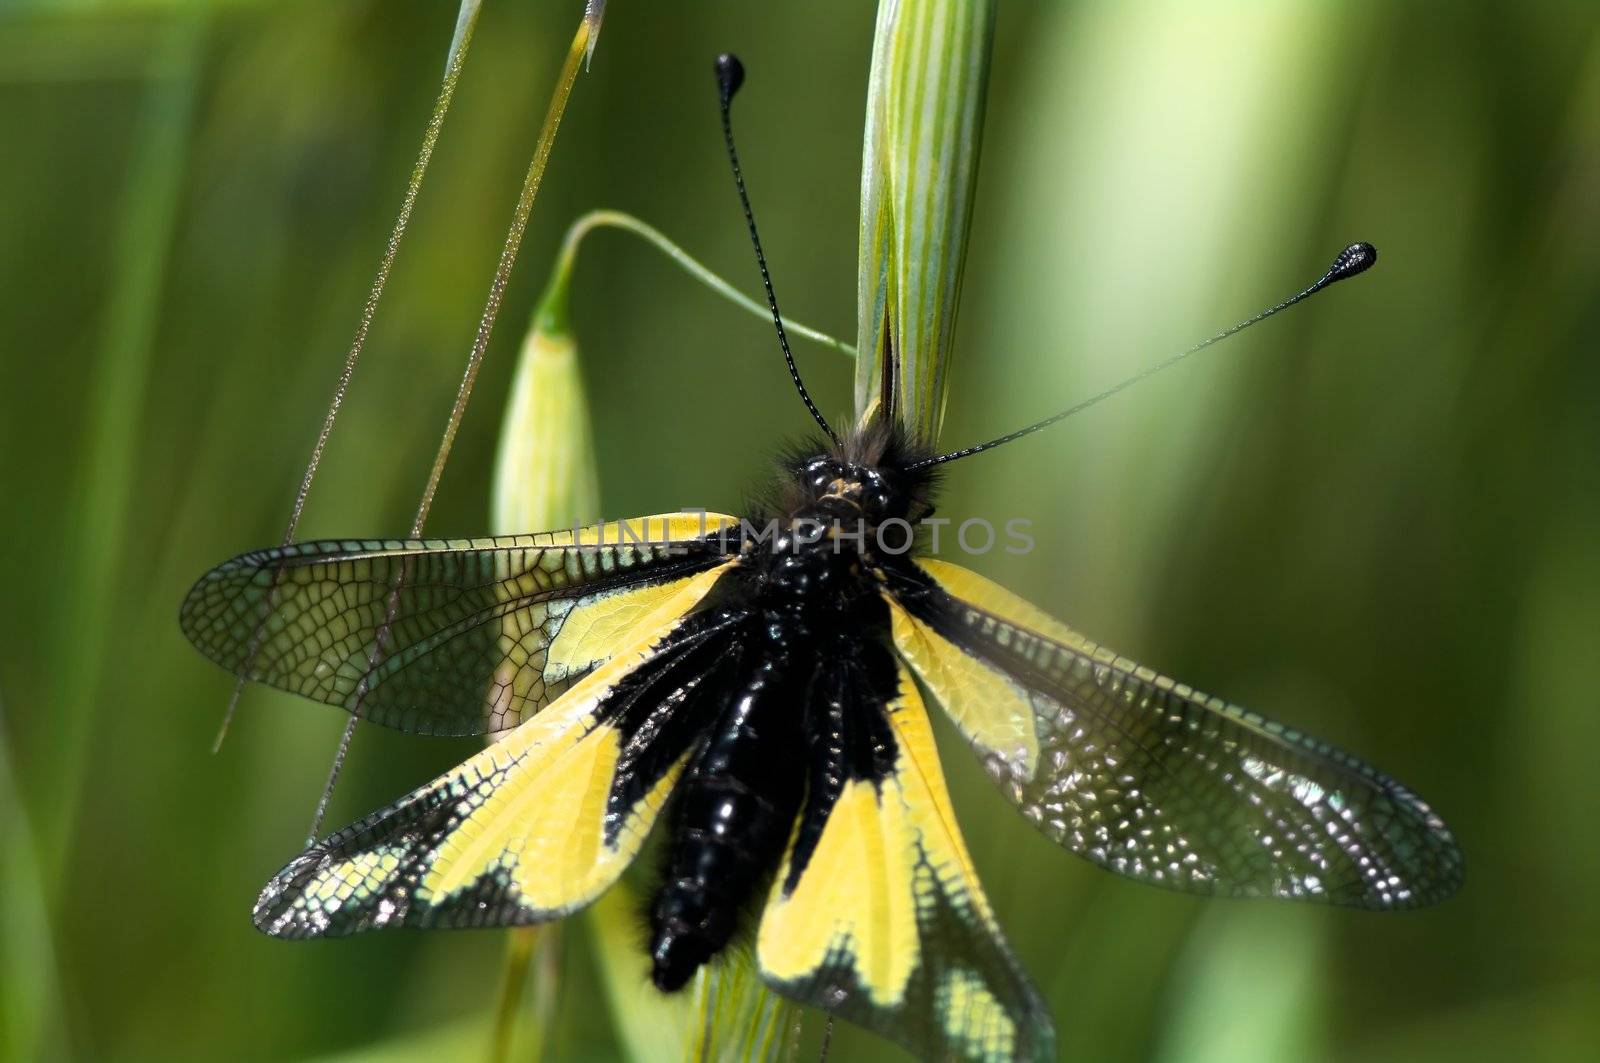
[179,514,733,735]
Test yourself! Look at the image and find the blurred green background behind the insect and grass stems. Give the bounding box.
[0,0,1600,1060]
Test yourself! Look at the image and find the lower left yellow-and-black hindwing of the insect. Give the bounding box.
[254,573,731,938]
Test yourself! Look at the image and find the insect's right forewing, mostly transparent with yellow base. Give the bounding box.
[890,560,1461,908]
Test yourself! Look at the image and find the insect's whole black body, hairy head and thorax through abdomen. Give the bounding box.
[650,429,933,991]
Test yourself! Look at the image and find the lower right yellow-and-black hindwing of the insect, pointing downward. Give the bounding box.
[757,647,1054,1061]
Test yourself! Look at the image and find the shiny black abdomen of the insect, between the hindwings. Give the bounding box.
[650,652,805,991]
